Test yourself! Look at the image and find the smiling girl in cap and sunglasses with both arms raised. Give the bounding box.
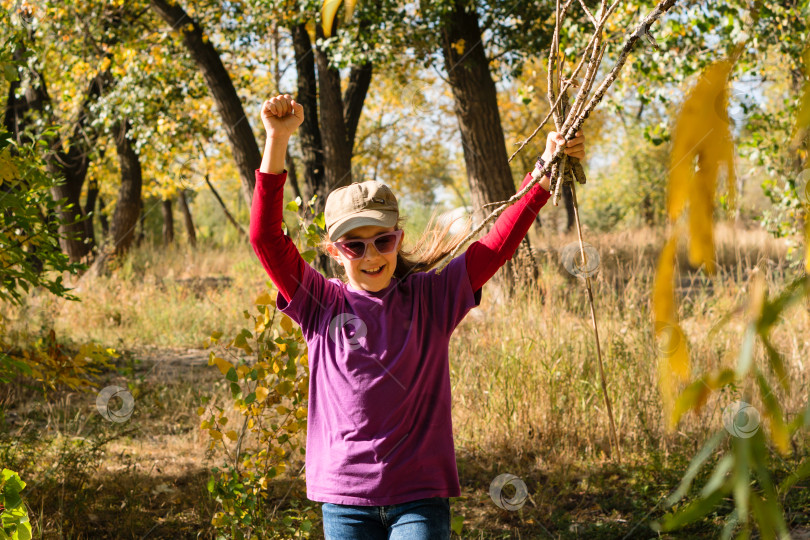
[250,94,585,540]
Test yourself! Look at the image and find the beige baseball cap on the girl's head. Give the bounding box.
[324,180,399,241]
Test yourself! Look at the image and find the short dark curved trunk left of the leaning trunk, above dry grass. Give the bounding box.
[112,121,143,255]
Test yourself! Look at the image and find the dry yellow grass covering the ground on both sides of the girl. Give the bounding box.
[0,225,810,538]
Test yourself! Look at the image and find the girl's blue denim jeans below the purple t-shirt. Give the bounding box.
[321,497,450,540]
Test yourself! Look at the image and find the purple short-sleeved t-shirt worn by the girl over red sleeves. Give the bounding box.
[277,254,481,506]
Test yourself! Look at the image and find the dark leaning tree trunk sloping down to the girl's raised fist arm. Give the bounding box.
[151,0,258,208]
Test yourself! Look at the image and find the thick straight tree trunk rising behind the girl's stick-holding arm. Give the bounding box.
[440,0,537,290]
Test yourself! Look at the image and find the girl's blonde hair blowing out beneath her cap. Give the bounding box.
[318,210,472,279]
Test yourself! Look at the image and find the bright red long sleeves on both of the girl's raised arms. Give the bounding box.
[250,169,551,302]
